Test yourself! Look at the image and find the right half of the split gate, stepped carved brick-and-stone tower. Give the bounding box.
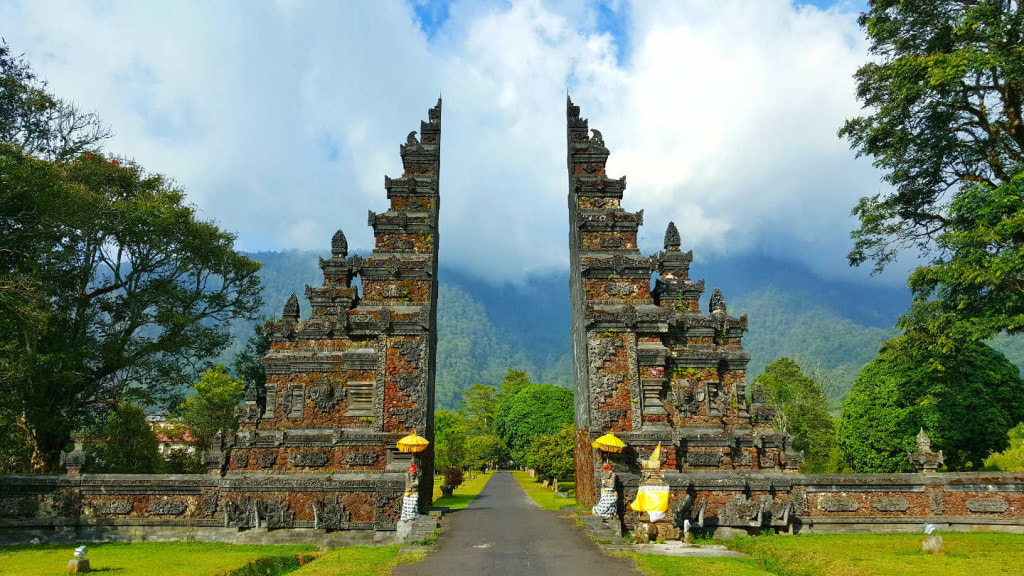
[566,100,801,505]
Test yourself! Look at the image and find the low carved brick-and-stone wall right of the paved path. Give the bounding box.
[602,471,1024,539]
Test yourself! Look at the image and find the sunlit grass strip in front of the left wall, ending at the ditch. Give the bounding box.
[0,542,313,576]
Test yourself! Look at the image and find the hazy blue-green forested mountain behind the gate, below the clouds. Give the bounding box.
[223,251,1024,408]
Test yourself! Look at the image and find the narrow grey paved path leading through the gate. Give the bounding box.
[391,471,638,576]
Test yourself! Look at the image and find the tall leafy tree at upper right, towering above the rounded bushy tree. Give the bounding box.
[840,0,1024,342]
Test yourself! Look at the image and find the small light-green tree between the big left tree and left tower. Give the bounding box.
[174,364,245,452]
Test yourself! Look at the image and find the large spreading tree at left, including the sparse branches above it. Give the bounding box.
[0,47,260,471]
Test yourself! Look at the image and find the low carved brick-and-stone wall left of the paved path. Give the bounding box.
[0,472,404,545]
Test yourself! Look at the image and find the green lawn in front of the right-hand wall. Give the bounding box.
[635,532,1024,576]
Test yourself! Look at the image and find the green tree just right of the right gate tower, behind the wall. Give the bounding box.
[754,358,836,474]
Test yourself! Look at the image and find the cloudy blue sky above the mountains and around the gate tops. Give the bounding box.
[0,0,902,282]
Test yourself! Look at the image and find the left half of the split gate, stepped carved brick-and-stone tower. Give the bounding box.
[227,99,441,530]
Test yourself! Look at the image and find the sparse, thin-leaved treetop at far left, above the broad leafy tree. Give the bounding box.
[0,43,110,161]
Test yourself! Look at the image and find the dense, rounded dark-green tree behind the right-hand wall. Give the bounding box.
[837,333,1024,472]
